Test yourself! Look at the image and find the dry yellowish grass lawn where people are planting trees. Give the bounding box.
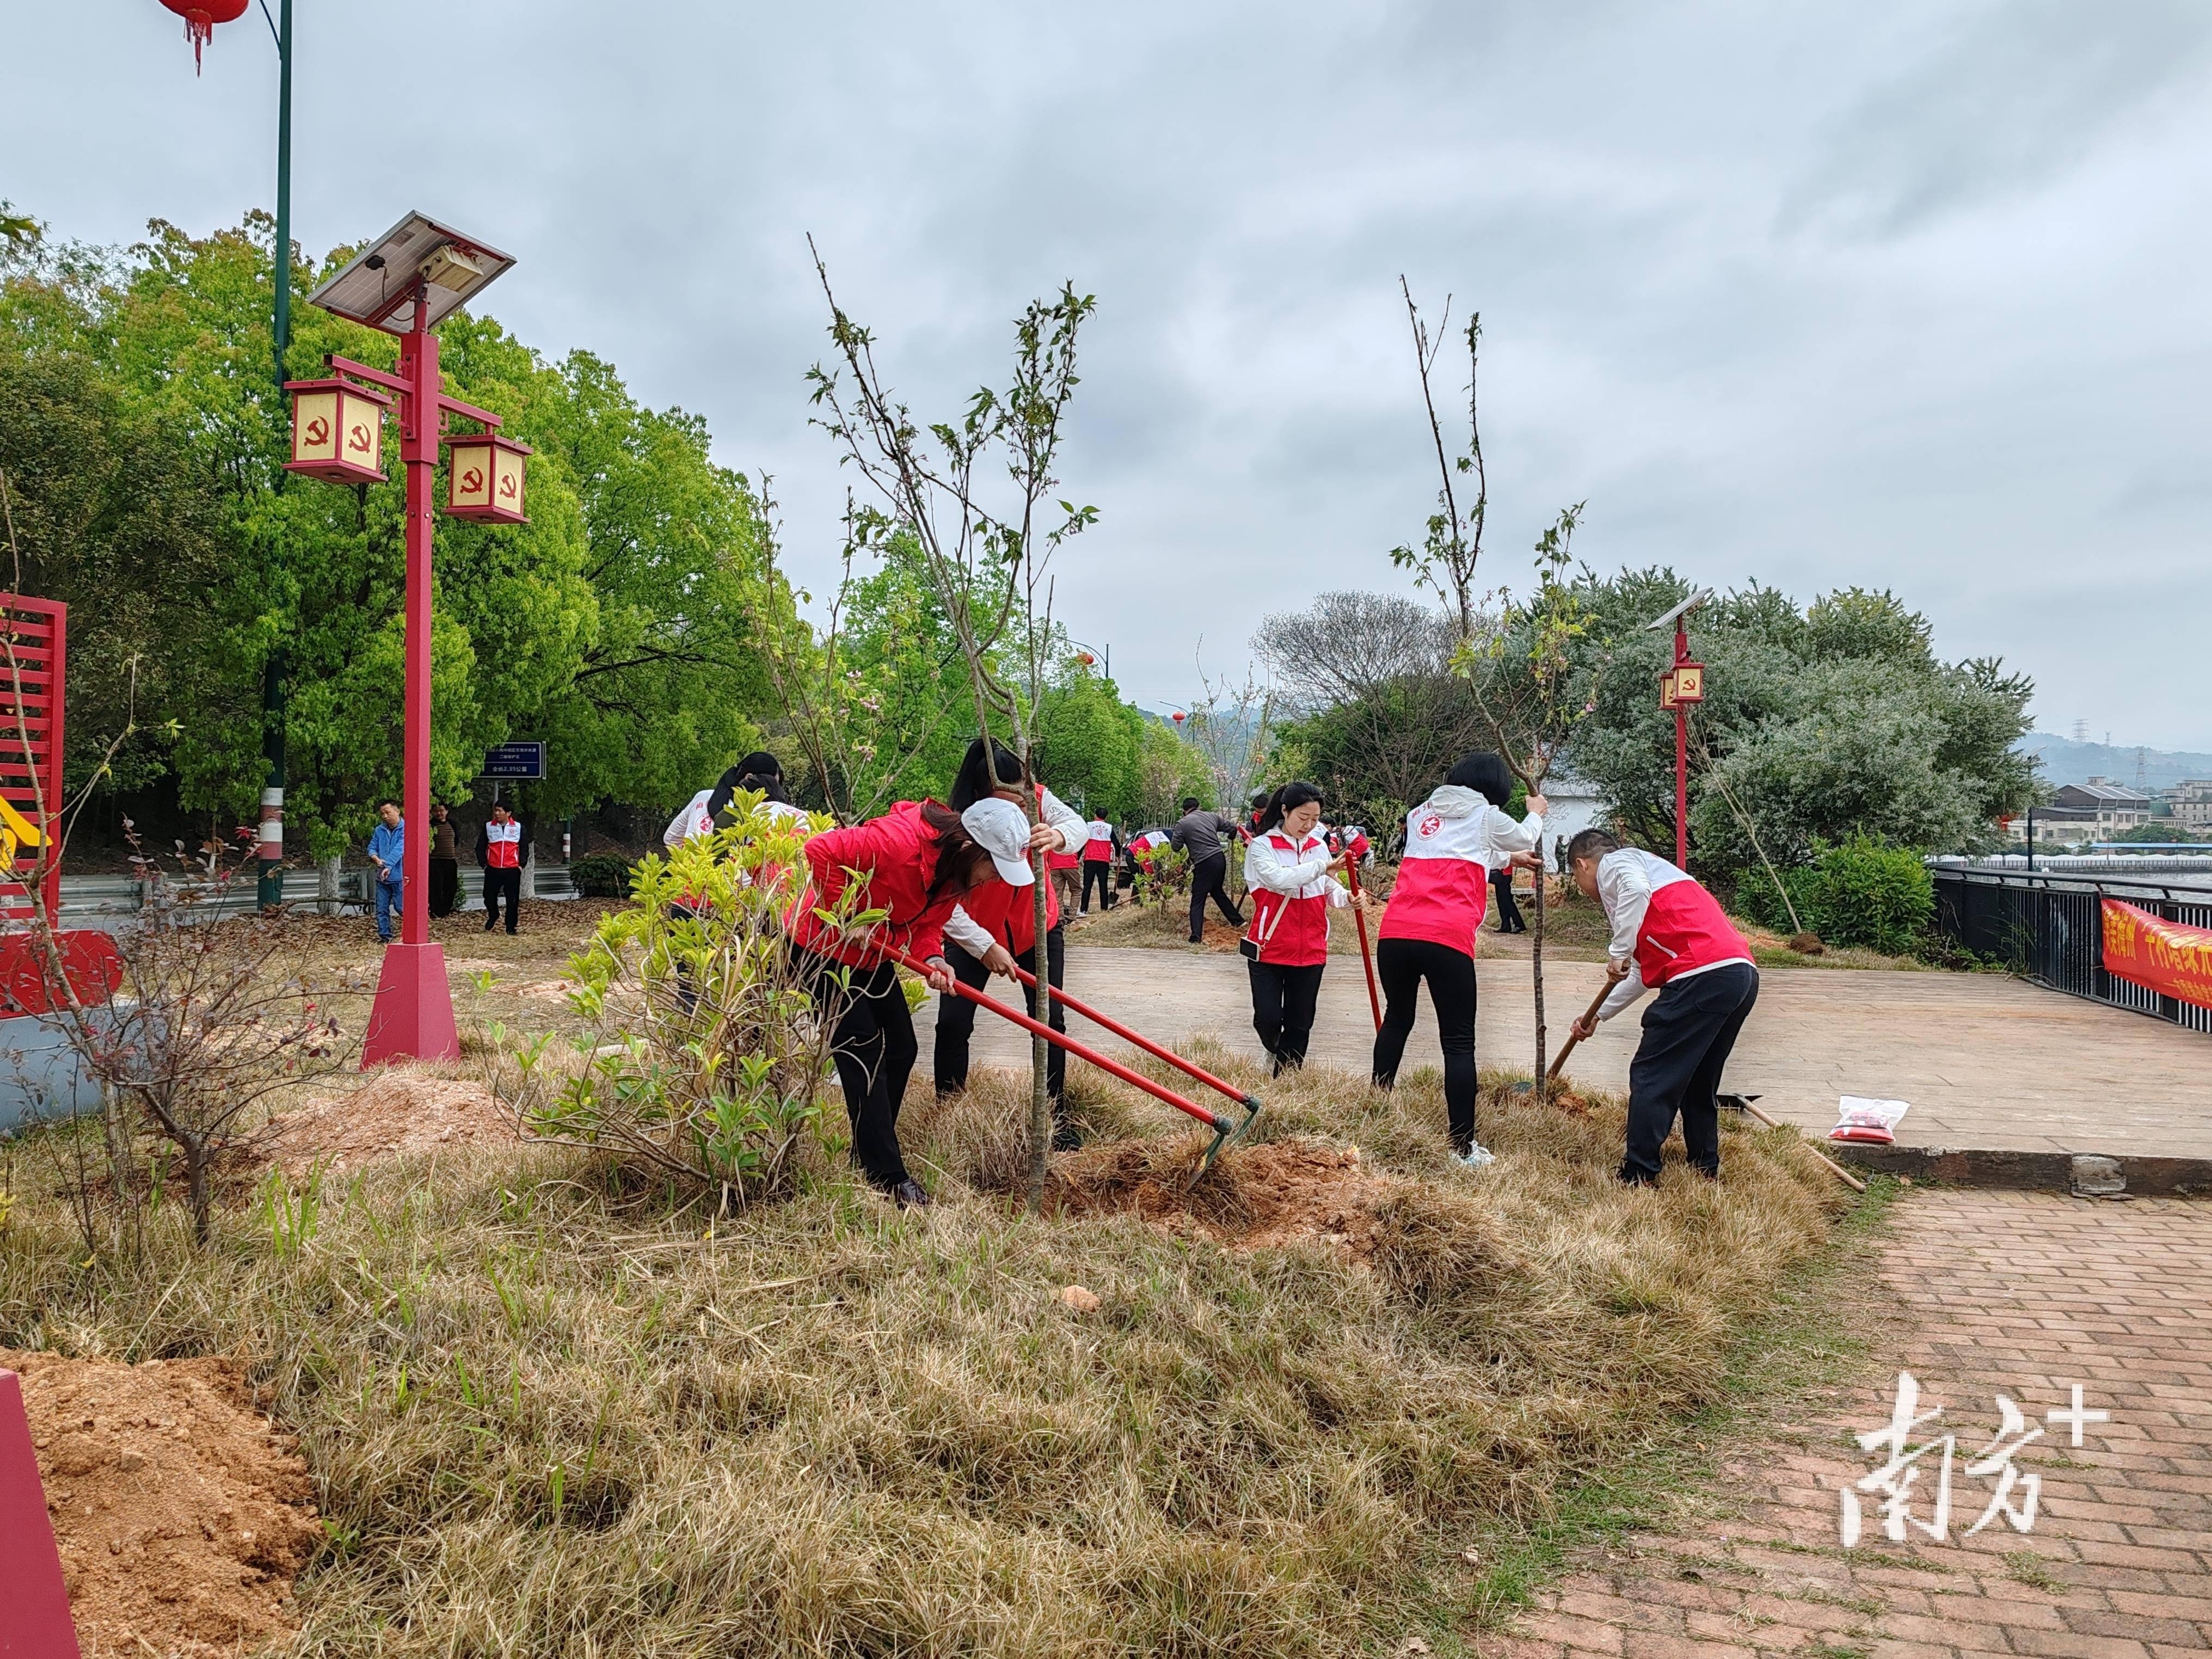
[0,907,1871,1659]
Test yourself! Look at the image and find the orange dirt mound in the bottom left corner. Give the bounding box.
[0,1349,323,1659]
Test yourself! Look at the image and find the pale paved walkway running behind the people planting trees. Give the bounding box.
[923,955,2212,1157]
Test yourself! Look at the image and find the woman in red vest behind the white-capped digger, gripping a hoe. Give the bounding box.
[931,736,1091,1150]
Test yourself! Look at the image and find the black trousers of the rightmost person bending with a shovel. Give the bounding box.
[1621,962,1759,1183]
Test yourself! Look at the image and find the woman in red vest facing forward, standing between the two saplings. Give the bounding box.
[1237,783,1351,1077]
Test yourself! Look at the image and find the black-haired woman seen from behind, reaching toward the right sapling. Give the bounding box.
[1374,754,1549,1170]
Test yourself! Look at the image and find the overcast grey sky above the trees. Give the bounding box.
[13,0,2212,750]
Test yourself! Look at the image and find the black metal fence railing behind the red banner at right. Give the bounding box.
[1931,869,2212,1033]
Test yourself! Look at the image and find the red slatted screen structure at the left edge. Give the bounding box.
[0,593,69,929]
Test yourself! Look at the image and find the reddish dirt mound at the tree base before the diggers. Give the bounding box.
[1044,1139,1391,1261]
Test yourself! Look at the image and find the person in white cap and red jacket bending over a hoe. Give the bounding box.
[783,801,991,1210]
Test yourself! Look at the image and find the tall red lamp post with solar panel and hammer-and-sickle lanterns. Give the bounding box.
[285,212,529,1068]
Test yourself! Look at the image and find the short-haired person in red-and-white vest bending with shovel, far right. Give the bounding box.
[1566,830,1759,1185]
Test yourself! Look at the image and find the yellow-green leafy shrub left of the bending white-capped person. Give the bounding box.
[489,794,853,1201]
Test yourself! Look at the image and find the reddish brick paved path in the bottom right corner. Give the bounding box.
[1478,1192,2212,1659]
